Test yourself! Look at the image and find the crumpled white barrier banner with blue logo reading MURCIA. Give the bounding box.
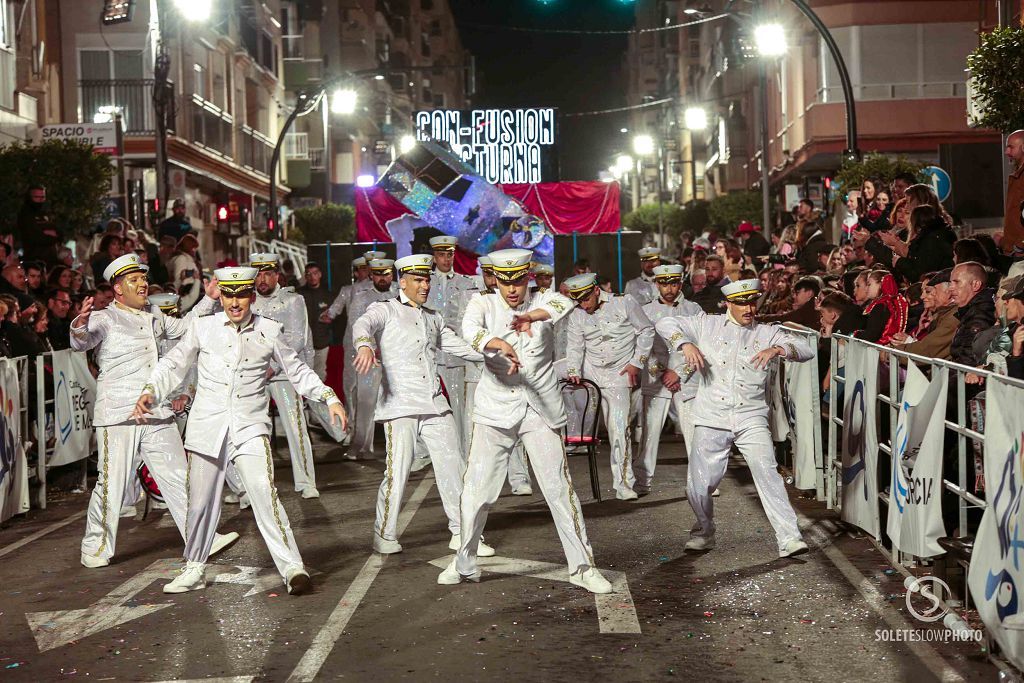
[886,362,949,557]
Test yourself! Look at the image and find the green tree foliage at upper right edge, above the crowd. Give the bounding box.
[967,27,1024,133]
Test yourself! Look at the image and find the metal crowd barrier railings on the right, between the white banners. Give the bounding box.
[826,335,1024,581]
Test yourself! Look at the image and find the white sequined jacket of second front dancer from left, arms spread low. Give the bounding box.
[142,312,338,457]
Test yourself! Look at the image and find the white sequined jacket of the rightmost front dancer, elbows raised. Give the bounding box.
[655,314,814,430]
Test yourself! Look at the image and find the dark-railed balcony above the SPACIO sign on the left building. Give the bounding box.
[78,79,175,136]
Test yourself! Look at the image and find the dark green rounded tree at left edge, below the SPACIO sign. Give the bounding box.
[0,140,114,238]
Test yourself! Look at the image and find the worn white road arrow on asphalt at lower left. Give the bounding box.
[25,559,282,655]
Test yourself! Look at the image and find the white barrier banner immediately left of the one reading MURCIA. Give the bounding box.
[843,344,880,538]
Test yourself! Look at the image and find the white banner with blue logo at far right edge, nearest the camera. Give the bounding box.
[968,377,1024,669]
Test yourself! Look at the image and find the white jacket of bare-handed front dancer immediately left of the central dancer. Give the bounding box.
[352,292,483,422]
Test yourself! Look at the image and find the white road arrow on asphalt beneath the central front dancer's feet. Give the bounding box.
[430,555,640,633]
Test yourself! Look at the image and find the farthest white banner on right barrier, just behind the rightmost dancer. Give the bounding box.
[784,352,824,496]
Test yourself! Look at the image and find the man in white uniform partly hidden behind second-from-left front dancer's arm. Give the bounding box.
[249,253,319,498]
